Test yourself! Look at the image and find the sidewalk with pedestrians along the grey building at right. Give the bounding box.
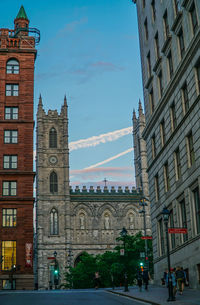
[109,285,200,305]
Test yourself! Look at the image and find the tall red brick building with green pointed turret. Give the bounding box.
[0,6,39,289]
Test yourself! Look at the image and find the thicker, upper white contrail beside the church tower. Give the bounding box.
[69,127,133,151]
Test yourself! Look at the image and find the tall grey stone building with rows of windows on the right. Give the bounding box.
[133,0,200,288]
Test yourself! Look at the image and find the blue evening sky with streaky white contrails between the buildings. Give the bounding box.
[0,0,143,186]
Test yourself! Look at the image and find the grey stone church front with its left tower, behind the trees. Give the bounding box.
[36,97,150,289]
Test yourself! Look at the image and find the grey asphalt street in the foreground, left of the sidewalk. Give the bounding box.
[0,289,150,305]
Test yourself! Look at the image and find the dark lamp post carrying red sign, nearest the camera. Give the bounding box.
[162,206,175,302]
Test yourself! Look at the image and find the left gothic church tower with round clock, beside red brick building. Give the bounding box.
[36,96,70,289]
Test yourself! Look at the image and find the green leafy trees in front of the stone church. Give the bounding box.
[65,232,153,288]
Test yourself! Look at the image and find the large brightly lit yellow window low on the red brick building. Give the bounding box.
[1,241,16,270]
